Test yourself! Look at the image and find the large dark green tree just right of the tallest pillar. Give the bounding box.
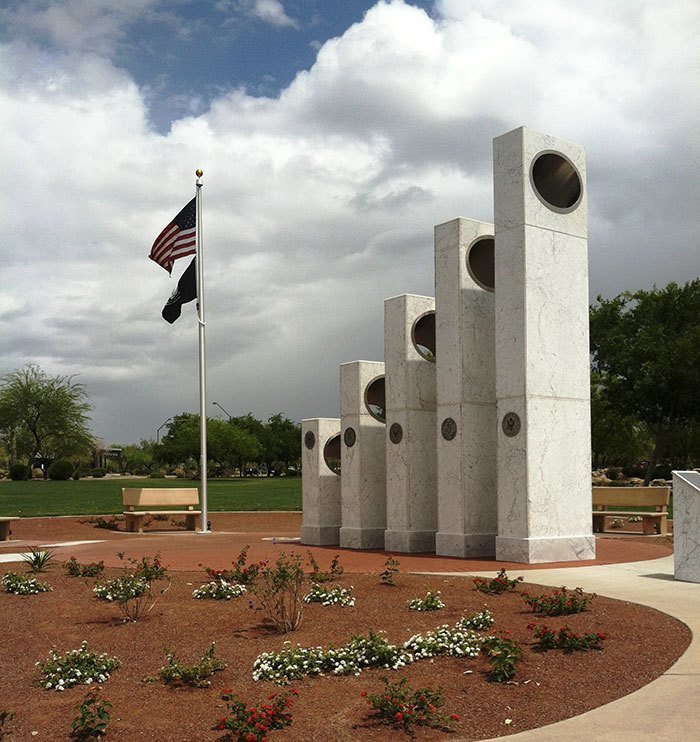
[590,279,700,484]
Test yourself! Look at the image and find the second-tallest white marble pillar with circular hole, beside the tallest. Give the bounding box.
[435,219,498,557]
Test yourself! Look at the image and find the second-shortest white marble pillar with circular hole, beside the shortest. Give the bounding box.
[340,361,386,549]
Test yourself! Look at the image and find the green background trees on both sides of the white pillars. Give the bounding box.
[0,279,700,483]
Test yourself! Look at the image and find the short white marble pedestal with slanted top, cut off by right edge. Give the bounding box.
[673,471,700,582]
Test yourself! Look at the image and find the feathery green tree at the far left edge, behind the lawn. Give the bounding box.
[0,363,94,472]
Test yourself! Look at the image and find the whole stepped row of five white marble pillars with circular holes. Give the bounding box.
[301,128,595,563]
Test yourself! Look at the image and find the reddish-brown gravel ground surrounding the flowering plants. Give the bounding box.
[0,513,690,742]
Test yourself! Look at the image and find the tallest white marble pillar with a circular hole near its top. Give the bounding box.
[493,128,595,563]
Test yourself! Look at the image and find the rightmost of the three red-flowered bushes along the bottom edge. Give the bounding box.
[362,678,459,734]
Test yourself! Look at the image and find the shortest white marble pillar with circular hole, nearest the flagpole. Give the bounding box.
[301,417,341,546]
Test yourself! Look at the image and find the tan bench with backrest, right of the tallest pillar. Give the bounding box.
[593,487,671,536]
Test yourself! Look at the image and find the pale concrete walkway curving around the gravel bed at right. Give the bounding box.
[455,556,700,742]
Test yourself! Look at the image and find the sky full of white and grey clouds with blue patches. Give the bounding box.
[0,0,700,443]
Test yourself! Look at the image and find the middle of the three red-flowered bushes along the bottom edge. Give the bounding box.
[214,688,298,742]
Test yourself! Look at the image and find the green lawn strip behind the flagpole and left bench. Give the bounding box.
[0,477,301,518]
